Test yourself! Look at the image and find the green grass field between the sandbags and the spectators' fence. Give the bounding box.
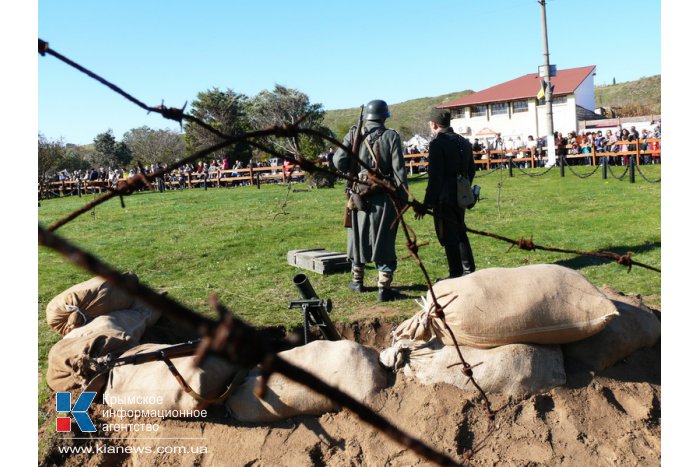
[38,165,661,401]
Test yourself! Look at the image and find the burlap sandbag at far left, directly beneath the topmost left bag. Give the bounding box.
[46,309,152,391]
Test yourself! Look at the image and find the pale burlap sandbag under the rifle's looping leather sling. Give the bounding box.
[104,344,247,411]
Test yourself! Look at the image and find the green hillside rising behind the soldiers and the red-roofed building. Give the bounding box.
[324,75,661,139]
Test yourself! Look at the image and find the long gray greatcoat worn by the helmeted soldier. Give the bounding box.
[333,121,407,272]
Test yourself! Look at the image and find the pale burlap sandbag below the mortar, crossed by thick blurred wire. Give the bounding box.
[226,340,387,422]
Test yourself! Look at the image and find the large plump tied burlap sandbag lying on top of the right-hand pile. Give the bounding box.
[393,264,617,349]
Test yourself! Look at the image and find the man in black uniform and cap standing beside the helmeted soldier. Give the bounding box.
[417,109,476,278]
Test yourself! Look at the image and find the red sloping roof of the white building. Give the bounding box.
[438,65,595,108]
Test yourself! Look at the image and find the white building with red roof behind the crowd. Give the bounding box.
[439,66,601,141]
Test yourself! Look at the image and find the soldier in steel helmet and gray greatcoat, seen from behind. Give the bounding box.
[331,100,407,302]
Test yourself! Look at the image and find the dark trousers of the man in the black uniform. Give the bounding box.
[434,203,476,278]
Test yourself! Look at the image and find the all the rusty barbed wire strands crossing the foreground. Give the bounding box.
[39,39,660,465]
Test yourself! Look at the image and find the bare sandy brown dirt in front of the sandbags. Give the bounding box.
[40,298,661,466]
